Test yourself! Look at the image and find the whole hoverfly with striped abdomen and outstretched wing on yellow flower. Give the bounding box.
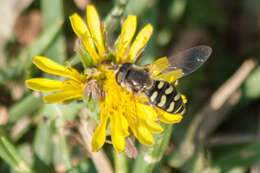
[115,46,212,114]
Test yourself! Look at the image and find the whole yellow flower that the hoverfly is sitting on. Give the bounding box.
[26,5,185,152]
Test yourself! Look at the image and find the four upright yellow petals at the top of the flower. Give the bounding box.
[70,5,153,66]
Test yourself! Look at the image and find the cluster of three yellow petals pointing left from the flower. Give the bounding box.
[26,56,87,103]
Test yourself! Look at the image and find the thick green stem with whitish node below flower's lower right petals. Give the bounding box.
[132,124,173,173]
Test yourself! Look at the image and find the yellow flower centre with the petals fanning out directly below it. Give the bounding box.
[92,68,163,152]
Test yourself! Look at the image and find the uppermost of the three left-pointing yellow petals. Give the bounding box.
[33,56,80,80]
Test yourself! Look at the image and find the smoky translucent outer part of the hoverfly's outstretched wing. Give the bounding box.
[166,46,212,77]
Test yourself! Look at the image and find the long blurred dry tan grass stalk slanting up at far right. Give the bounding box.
[170,59,256,169]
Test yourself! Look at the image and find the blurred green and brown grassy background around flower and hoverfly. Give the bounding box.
[0,0,260,173]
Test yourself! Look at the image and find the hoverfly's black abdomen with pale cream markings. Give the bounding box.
[144,80,185,114]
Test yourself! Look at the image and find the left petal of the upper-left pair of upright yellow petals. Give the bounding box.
[70,13,99,65]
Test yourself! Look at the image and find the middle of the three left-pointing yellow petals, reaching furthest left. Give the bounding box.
[25,78,63,91]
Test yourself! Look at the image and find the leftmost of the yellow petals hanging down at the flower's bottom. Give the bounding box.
[91,113,108,152]
